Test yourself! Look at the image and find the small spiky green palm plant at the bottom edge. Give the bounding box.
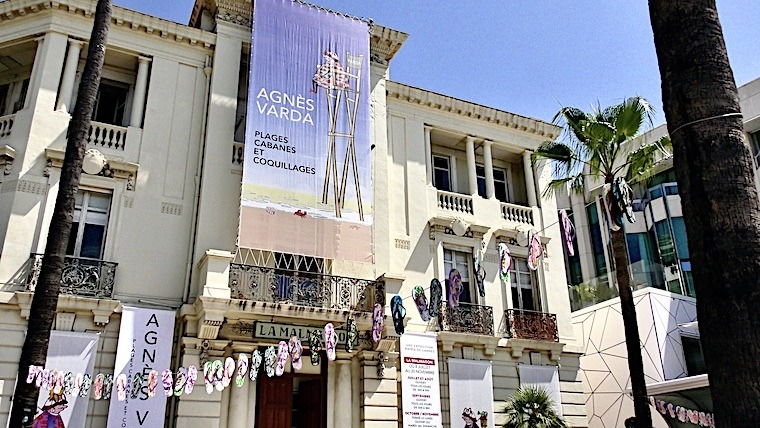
[503,385,569,428]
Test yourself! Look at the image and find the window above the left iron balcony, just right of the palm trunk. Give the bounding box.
[66,190,111,259]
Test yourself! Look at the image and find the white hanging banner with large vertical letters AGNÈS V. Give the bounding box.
[108,306,175,428]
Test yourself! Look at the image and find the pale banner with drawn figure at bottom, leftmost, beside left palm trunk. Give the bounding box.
[35,330,100,428]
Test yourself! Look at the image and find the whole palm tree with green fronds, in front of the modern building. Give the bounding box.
[534,97,670,428]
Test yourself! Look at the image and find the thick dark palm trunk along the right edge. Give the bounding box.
[649,0,760,427]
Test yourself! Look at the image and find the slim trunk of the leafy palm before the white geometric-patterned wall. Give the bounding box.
[610,201,652,428]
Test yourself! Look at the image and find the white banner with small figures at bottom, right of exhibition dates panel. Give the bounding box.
[448,358,494,428]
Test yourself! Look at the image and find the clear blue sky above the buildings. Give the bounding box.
[115,0,760,124]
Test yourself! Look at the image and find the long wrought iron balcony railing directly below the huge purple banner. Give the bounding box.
[229,263,385,312]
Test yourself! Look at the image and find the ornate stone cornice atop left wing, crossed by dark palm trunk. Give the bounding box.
[0,0,216,48]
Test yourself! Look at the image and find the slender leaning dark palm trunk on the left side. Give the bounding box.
[8,0,111,427]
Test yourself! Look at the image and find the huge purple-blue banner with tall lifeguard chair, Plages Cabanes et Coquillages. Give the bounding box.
[238,0,373,262]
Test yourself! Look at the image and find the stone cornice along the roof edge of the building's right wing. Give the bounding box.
[386,81,562,140]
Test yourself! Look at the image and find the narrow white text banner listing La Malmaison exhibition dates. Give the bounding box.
[400,333,442,428]
